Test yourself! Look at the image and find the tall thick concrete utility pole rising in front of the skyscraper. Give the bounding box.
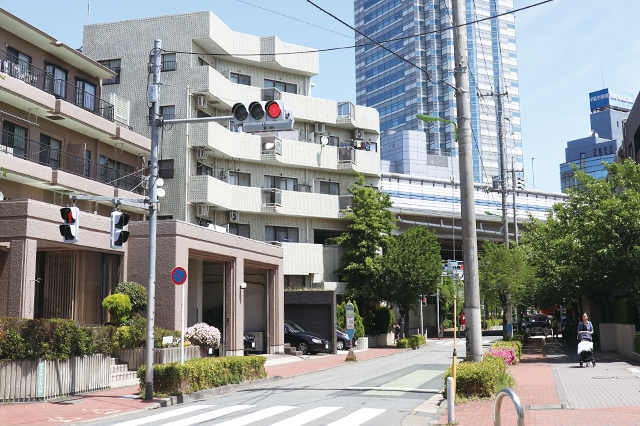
[452,0,482,362]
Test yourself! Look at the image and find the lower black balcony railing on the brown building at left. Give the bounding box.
[0,130,144,194]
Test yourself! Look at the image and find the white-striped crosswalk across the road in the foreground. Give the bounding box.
[111,405,386,426]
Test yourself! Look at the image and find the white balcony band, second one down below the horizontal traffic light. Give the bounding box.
[188,175,350,219]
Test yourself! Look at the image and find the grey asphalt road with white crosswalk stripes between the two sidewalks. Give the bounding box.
[87,336,500,426]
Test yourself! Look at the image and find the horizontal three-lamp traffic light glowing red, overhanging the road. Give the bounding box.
[231,100,295,132]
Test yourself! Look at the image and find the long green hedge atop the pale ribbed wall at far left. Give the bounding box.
[0,315,180,360]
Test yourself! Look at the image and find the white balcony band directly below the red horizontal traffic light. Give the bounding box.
[191,123,380,176]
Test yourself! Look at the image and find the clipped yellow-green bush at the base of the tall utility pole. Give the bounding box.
[442,356,507,398]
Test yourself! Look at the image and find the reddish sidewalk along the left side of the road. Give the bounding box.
[0,348,402,426]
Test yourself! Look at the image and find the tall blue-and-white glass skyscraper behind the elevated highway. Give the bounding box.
[355,0,522,184]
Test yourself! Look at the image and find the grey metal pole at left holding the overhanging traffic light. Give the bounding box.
[145,39,162,400]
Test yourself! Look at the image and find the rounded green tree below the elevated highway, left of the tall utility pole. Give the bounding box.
[379,226,442,335]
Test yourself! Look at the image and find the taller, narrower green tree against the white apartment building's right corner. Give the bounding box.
[336,174,396,302]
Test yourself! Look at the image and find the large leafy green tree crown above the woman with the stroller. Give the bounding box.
[524,160,640,321]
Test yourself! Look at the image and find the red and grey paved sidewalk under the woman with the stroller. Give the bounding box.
[440,339,640,426]
